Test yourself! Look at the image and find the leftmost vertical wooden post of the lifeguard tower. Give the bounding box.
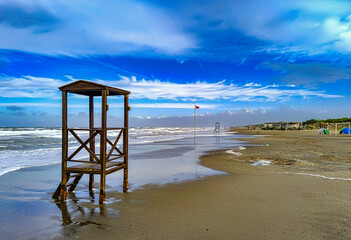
[60,91,68,202]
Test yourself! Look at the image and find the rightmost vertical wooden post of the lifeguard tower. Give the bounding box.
[123,95,129,192]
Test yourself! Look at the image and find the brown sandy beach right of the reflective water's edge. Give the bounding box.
[58,131,351,239]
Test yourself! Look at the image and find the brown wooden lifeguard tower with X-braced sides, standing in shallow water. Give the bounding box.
[52,80,130,204]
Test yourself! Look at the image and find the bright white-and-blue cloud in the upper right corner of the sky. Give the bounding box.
[203,0,351,54]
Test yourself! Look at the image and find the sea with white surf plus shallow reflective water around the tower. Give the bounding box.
[0,127,253,239]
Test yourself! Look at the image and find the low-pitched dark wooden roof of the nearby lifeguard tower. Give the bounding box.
[59,80,130,96]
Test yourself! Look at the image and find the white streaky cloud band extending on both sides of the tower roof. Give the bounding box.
[0,76,341,102]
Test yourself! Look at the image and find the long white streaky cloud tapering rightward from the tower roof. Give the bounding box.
[97,76,341,101]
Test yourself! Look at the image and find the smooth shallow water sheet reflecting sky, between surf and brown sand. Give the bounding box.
[0,132,250,239]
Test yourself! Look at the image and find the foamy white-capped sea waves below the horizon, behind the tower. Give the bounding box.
[0,127,223,176]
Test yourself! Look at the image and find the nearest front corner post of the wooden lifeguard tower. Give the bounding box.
[99,90,108,204]
